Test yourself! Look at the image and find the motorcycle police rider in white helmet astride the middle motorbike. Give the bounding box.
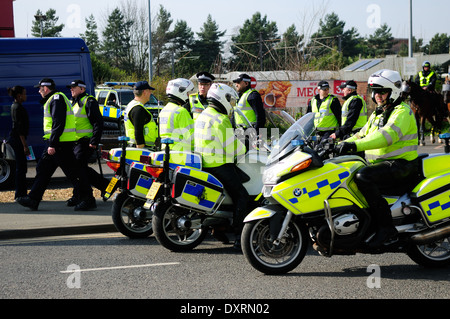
[194,83,249,249]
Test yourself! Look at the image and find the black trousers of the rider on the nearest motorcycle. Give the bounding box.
[355,159,419,227]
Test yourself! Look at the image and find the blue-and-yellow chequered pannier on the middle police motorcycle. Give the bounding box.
[172,167,224,212]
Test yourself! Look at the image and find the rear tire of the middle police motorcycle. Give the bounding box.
[152,202,208,252]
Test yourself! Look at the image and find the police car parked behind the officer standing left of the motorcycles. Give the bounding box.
[95,82,163,126]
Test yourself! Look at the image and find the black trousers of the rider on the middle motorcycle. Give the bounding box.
[203,163,250,234]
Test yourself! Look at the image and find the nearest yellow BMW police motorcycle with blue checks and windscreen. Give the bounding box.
[241,113,450,275]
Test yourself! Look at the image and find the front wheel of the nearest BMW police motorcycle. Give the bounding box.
[241,219,308,275]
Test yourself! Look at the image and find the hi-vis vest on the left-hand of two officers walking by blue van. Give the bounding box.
[44,92,77,142]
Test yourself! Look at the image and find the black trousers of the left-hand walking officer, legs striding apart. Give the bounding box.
[28,142,92,201]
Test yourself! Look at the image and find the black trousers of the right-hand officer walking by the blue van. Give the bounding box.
[73,138,109,197]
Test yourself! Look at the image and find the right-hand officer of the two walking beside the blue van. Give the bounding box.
[67,80,108,207]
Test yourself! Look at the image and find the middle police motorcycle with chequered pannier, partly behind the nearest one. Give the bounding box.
[146,88,280,251]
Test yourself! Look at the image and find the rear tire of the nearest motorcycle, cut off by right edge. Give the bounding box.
[406,237,450,268]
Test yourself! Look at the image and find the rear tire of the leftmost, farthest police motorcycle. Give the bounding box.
[111,192,153,239]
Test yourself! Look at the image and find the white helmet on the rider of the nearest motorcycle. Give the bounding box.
[367,69,402,105]
